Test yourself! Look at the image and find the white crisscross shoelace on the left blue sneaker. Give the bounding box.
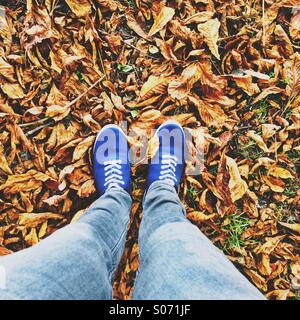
[103,160,125,191]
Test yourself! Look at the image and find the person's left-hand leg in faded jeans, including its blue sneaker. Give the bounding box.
[0,125,131,299]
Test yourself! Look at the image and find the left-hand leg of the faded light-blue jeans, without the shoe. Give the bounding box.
[0,190,131,300]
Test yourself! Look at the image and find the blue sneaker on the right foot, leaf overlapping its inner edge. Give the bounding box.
[148,120,185,188]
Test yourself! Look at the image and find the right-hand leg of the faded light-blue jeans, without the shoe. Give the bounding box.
[133,182,264,300]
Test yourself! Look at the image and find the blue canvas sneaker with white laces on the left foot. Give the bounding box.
[93,124,131,195]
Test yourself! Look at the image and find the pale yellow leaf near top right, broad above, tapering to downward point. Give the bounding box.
[198,18,221,60]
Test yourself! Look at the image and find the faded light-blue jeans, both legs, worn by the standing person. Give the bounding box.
[0,182,264,300]
